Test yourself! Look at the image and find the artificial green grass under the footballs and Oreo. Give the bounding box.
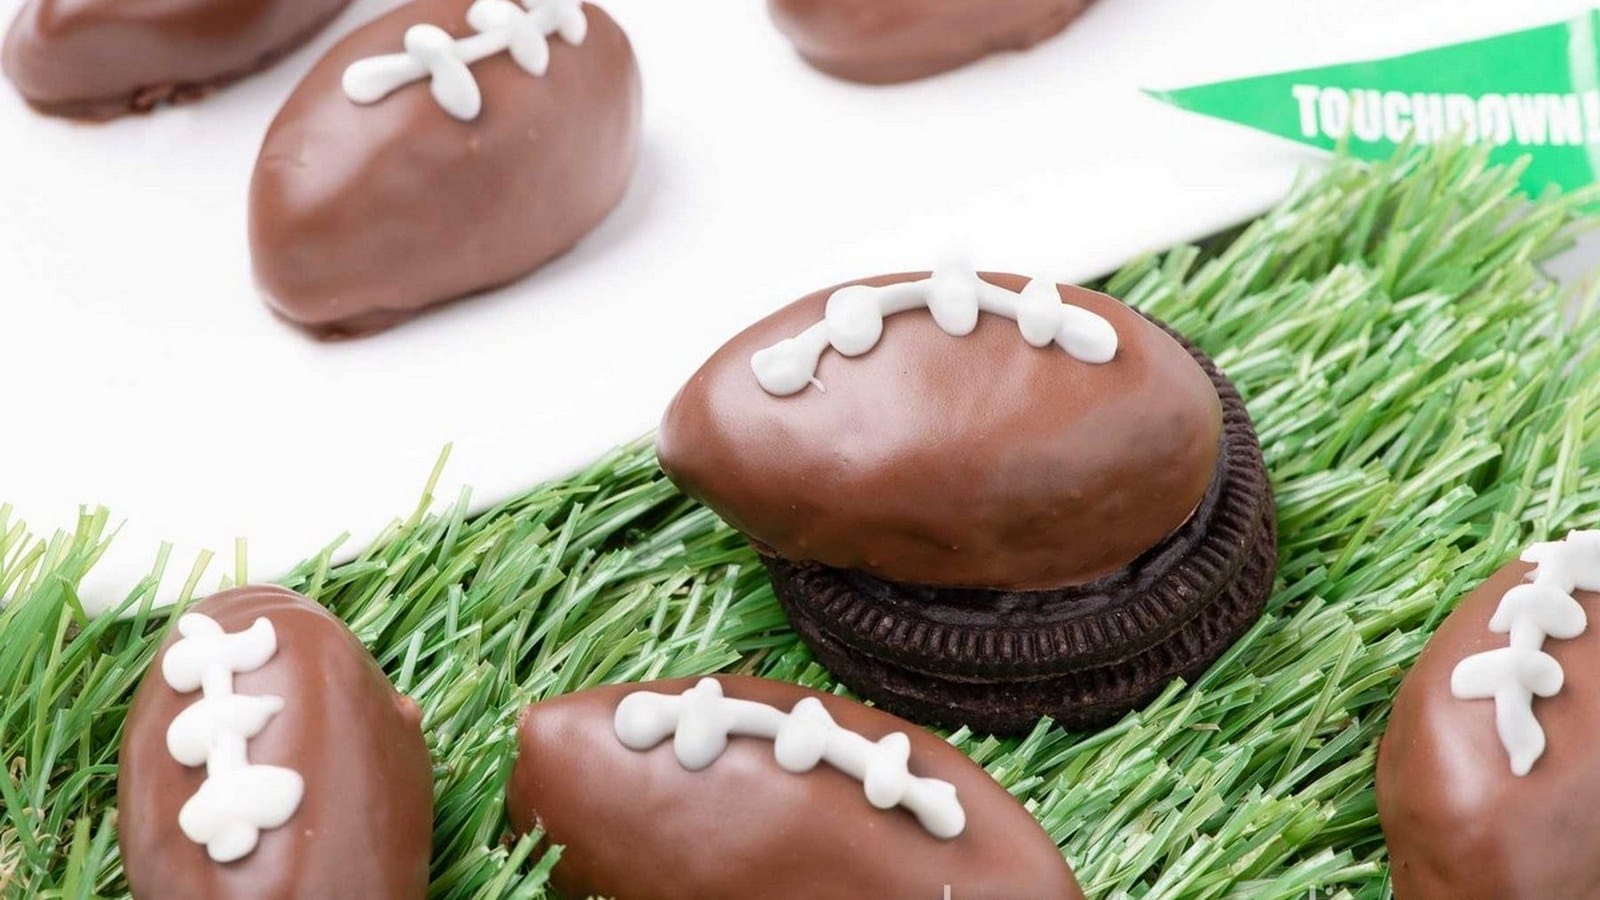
[0,149,1600,900]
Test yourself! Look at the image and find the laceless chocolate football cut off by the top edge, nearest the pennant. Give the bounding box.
[768,0,1090,83]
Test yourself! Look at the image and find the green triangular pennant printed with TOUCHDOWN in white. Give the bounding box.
[1146,11,1600,194]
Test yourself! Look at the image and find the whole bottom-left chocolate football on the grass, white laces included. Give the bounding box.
[117,586,434,900]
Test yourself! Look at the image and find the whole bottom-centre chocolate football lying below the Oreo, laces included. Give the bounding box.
[507,676,1082,900]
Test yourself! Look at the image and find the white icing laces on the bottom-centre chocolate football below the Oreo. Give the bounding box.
[613,677,966,839]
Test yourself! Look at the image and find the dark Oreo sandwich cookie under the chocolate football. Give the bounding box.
[763,327,1277,732]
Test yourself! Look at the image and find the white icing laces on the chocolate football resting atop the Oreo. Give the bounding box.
[750,267,1117,397]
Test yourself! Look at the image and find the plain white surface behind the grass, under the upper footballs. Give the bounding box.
[0,0,1587,602]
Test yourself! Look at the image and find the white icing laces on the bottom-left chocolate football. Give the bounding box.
[162,613,306,863]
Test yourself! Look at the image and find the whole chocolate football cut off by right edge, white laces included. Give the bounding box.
[1378,532,1600,900]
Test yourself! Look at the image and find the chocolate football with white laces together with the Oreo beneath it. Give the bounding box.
[658,271,1277,730]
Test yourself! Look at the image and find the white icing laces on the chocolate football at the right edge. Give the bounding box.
[1450,532,1600,775]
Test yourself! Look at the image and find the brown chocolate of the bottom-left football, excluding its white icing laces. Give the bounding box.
[117,586,434,900]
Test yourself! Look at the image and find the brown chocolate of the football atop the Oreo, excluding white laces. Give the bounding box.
[656,274,1222,589]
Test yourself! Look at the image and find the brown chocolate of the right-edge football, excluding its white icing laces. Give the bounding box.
[1378,562,1600,900]
